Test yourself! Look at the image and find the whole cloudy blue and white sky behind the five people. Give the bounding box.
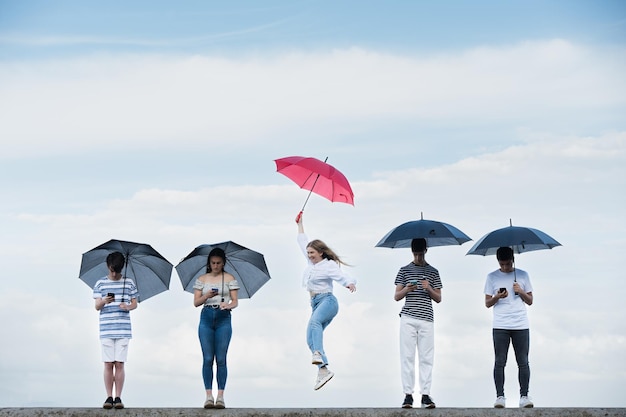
[0,0,626,408]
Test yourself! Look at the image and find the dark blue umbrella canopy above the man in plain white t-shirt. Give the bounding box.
[467,224,561,256]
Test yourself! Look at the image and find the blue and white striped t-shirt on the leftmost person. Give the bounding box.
[93,277,137,339]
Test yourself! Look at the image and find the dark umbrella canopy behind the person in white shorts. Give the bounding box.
[79,239,173,302]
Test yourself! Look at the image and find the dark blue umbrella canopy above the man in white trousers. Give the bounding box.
[376,214,472,248]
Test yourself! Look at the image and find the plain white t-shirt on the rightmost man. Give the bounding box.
[485,268,533,330]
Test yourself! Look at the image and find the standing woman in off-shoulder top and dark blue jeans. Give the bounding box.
[193,248,239,408]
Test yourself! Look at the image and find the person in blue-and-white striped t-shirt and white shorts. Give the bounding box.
[93,252,137,409]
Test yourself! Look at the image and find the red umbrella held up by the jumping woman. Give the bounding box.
[274,156,354,216]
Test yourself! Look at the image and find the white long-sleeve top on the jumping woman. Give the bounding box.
[298,233,356,293]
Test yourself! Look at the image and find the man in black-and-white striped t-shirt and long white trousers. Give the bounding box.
[394,239,443,408]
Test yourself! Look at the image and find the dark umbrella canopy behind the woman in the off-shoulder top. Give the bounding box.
[176,241,270,298]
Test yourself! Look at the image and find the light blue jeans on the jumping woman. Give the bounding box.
[306,293,339,367]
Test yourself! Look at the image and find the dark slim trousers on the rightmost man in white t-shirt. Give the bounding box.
[493,329,530,397]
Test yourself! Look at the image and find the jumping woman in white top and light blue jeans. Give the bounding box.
[296,212,356,390]
